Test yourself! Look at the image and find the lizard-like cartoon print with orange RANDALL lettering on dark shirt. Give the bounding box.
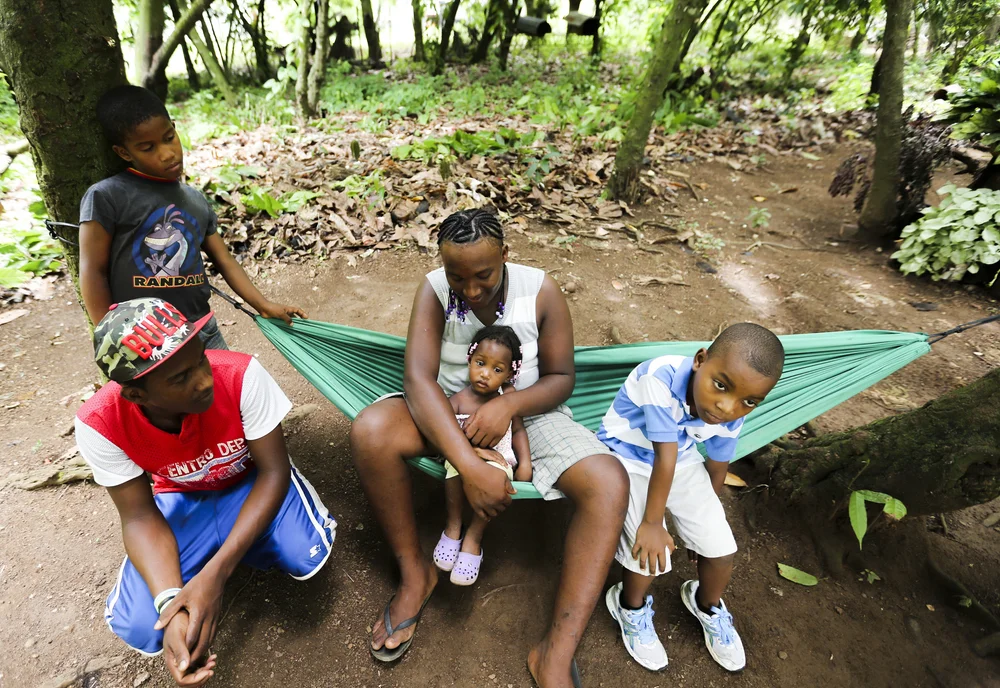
[132,204,205,287]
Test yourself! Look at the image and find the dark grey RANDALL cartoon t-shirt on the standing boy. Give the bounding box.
[80,170,218,320]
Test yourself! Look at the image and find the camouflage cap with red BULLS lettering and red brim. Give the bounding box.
[94,298,212,382]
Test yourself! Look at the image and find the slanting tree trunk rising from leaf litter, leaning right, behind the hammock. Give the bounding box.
[608,0,708,202]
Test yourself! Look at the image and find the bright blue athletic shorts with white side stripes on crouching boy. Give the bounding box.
[104,466,337,655]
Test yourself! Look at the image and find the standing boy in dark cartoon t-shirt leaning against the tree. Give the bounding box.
[80,86,306,349]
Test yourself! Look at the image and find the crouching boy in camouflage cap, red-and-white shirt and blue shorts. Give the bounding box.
[76,299,337,686]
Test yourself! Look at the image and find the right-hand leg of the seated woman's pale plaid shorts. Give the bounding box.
[524,405,611,500]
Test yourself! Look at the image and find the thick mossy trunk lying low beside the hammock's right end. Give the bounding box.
[750,368,1000,516]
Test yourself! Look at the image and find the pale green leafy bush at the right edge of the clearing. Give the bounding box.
[892,184,1000,281]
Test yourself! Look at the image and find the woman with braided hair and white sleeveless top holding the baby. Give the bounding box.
[351,210,628,688]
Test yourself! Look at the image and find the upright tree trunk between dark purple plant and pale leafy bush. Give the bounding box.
[858,0,911,239]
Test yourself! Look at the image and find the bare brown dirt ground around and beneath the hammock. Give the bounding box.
[0,149,1000,688]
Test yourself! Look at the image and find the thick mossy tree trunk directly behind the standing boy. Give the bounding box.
[0,0,128,310]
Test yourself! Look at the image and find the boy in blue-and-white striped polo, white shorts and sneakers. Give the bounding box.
[597,323,785,671]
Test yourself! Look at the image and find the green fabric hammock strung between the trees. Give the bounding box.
[255,316,930,499]
